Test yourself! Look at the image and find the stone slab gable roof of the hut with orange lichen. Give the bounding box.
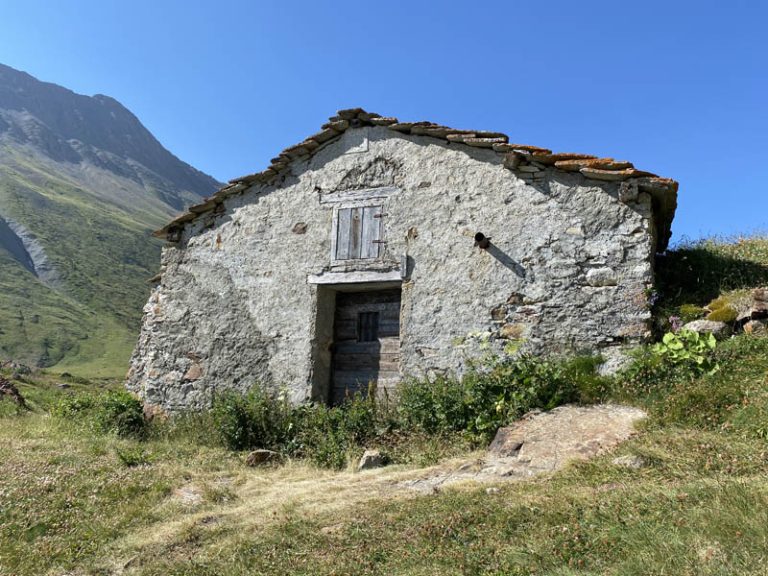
[154,108,678,251]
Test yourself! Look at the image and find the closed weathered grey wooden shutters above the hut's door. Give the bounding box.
[336,206,382,260]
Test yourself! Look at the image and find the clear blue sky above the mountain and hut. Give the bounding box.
[0,0,768,240]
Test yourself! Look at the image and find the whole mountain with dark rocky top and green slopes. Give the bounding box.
[0,64,220,375]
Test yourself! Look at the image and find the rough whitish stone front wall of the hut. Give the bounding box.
[128,127,654,411]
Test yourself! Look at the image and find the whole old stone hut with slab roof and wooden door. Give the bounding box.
[127,109,677,411]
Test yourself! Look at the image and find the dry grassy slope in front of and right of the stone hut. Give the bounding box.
[0,238,768,576]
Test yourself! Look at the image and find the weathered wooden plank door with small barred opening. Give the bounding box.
[331,288,400,404]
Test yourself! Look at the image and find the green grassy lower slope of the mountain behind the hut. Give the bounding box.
[0,149,171,376]
